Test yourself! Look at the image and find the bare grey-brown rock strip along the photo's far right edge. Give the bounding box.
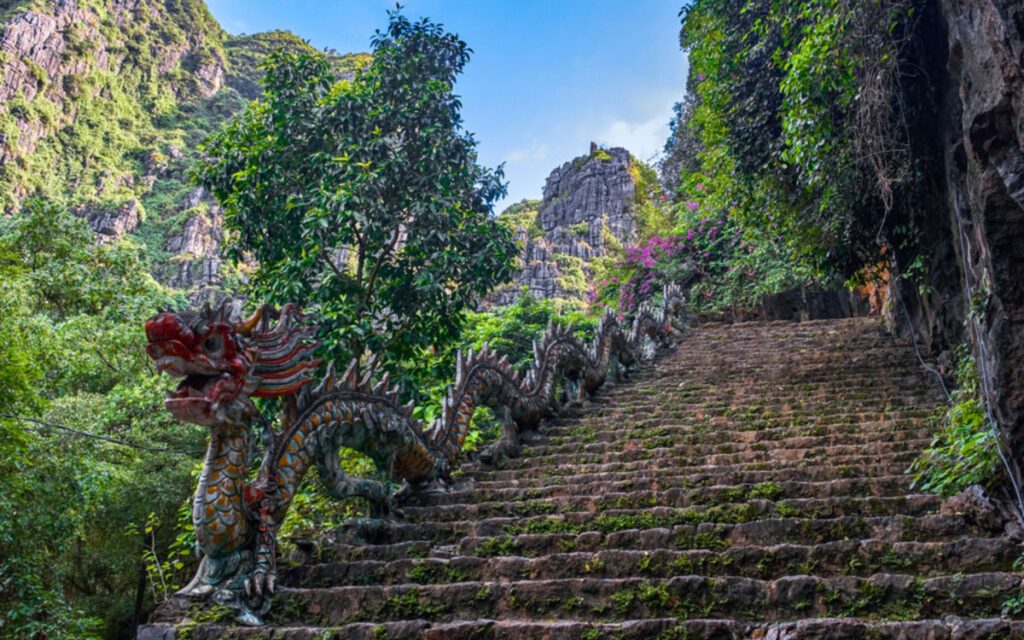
[941,0,1024,459]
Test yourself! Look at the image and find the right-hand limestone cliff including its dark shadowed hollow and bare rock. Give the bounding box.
[892,0,1024,461]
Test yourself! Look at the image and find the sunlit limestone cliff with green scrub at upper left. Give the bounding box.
[0,0,367,299]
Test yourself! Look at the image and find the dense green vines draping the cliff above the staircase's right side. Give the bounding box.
[668,0,913,278]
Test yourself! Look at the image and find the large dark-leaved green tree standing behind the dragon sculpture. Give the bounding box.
[199,12,516,374]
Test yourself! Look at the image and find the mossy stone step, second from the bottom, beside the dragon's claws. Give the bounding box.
[268,572,1021,626]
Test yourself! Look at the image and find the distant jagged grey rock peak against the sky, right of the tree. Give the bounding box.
[487,145,636,305]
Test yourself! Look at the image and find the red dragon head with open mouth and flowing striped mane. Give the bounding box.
[145,304,319,427]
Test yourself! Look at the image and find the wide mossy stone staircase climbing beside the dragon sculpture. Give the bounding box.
[151,319,1024,640]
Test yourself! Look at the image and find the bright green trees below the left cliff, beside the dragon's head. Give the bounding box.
[0,201,206,638]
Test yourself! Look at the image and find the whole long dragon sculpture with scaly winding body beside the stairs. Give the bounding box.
[145,287,685,625]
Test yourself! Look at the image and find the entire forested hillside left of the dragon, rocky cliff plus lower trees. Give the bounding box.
[0,0,367,637]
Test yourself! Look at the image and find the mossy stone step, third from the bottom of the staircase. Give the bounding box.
[283,538,1020,588]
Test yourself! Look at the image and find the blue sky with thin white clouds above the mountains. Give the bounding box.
[207,0,686,210]
